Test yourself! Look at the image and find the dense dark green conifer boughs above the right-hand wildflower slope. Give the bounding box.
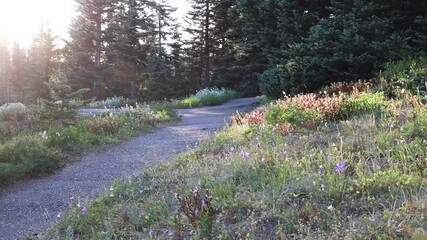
[259,0,427,96]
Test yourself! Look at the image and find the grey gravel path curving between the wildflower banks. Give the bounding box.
[0,98,257,240]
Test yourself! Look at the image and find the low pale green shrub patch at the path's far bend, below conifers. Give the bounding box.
[174,88,239,108]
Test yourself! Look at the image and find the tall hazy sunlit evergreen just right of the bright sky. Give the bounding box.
[67,0,116,97]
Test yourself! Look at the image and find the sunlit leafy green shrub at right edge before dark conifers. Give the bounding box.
[379,57,427,97]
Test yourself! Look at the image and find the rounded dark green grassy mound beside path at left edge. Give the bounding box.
[0,136,60,185]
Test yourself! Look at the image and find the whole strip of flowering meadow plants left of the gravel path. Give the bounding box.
[0,103,177,186]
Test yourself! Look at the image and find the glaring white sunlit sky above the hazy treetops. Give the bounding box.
[0,0,74,47]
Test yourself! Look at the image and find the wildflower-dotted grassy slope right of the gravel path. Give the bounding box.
[42,85,427,239]
